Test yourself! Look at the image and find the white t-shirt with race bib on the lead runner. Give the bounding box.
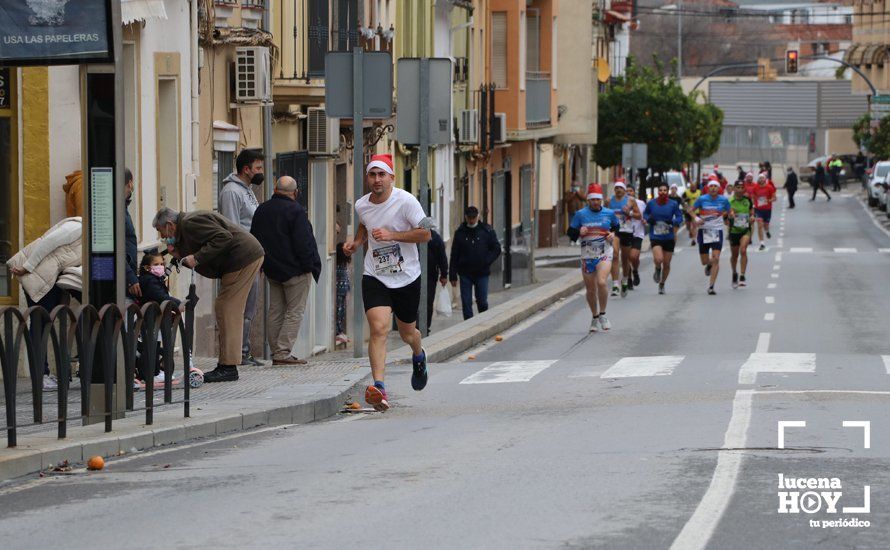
[355,187,426,288]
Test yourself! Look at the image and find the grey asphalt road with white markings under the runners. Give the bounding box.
[0,195,890,549]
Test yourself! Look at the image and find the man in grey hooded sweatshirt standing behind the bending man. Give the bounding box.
[219,149,266,367]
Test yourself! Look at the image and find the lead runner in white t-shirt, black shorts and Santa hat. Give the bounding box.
[343,155,431,411]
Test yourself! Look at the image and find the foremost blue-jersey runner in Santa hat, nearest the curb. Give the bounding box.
[568,183,620,332]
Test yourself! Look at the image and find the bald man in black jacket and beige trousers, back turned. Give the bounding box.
[250,176,321,365]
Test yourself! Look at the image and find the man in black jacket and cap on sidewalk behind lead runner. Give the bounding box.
[448,206,501,319]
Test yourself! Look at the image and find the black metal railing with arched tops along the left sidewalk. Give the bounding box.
[0,284,198,447]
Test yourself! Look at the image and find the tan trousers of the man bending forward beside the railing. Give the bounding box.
[214,258,263,365]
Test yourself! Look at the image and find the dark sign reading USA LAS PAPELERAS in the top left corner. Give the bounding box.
[0,0,113,65]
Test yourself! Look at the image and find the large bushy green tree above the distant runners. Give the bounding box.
[595,58,723,172]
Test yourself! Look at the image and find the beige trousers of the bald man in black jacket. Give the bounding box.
[269,273,312,359]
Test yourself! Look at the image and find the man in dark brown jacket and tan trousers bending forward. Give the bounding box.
[152,207,263,382]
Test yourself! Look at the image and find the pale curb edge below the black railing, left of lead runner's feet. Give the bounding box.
[0,369,371,481]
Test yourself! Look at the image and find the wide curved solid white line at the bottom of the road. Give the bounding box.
[671,390,754,550]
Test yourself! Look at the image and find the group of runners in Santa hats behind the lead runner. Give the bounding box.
[568,172,776,332]
